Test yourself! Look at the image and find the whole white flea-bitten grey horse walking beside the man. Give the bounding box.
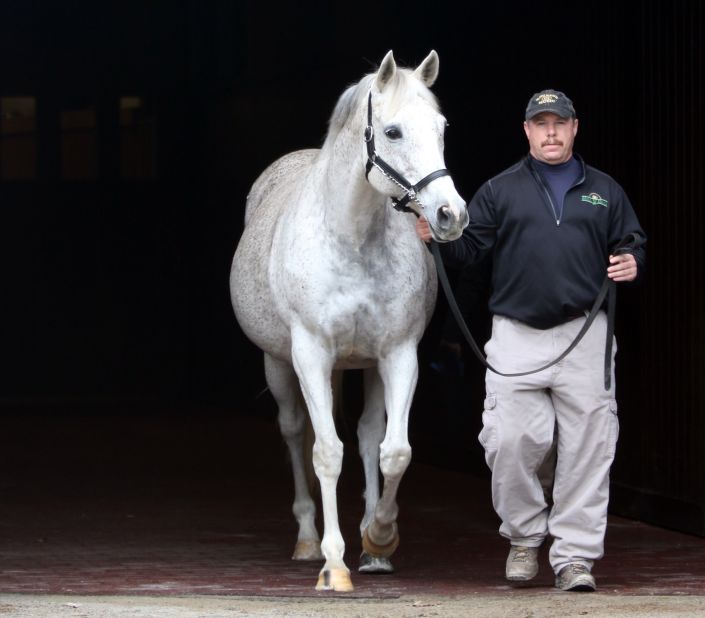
[230,51,468,591]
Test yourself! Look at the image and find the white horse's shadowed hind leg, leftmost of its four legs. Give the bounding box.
[264,354,323,560]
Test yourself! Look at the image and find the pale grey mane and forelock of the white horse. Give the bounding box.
[323,67,439,148]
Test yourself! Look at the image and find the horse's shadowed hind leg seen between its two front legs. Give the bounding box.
[357,367,394,573]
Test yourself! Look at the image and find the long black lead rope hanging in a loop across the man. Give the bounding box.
[431,234,644,391]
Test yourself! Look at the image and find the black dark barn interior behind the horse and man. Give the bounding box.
[0,0,705,534]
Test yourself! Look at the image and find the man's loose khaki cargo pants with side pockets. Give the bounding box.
[479,312,619,573]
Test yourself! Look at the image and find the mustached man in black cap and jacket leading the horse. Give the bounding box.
[417,90,645,591]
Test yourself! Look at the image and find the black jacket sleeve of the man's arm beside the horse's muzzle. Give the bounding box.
[440,181,497,268]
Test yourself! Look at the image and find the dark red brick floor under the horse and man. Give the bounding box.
[0,415,705,598]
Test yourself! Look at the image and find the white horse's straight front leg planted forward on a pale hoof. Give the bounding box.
[292,327,353,592]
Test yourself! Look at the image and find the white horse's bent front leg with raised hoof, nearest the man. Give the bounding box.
[362,343,418,558]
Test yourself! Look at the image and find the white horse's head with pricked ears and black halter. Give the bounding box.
[365,51,468,241]
